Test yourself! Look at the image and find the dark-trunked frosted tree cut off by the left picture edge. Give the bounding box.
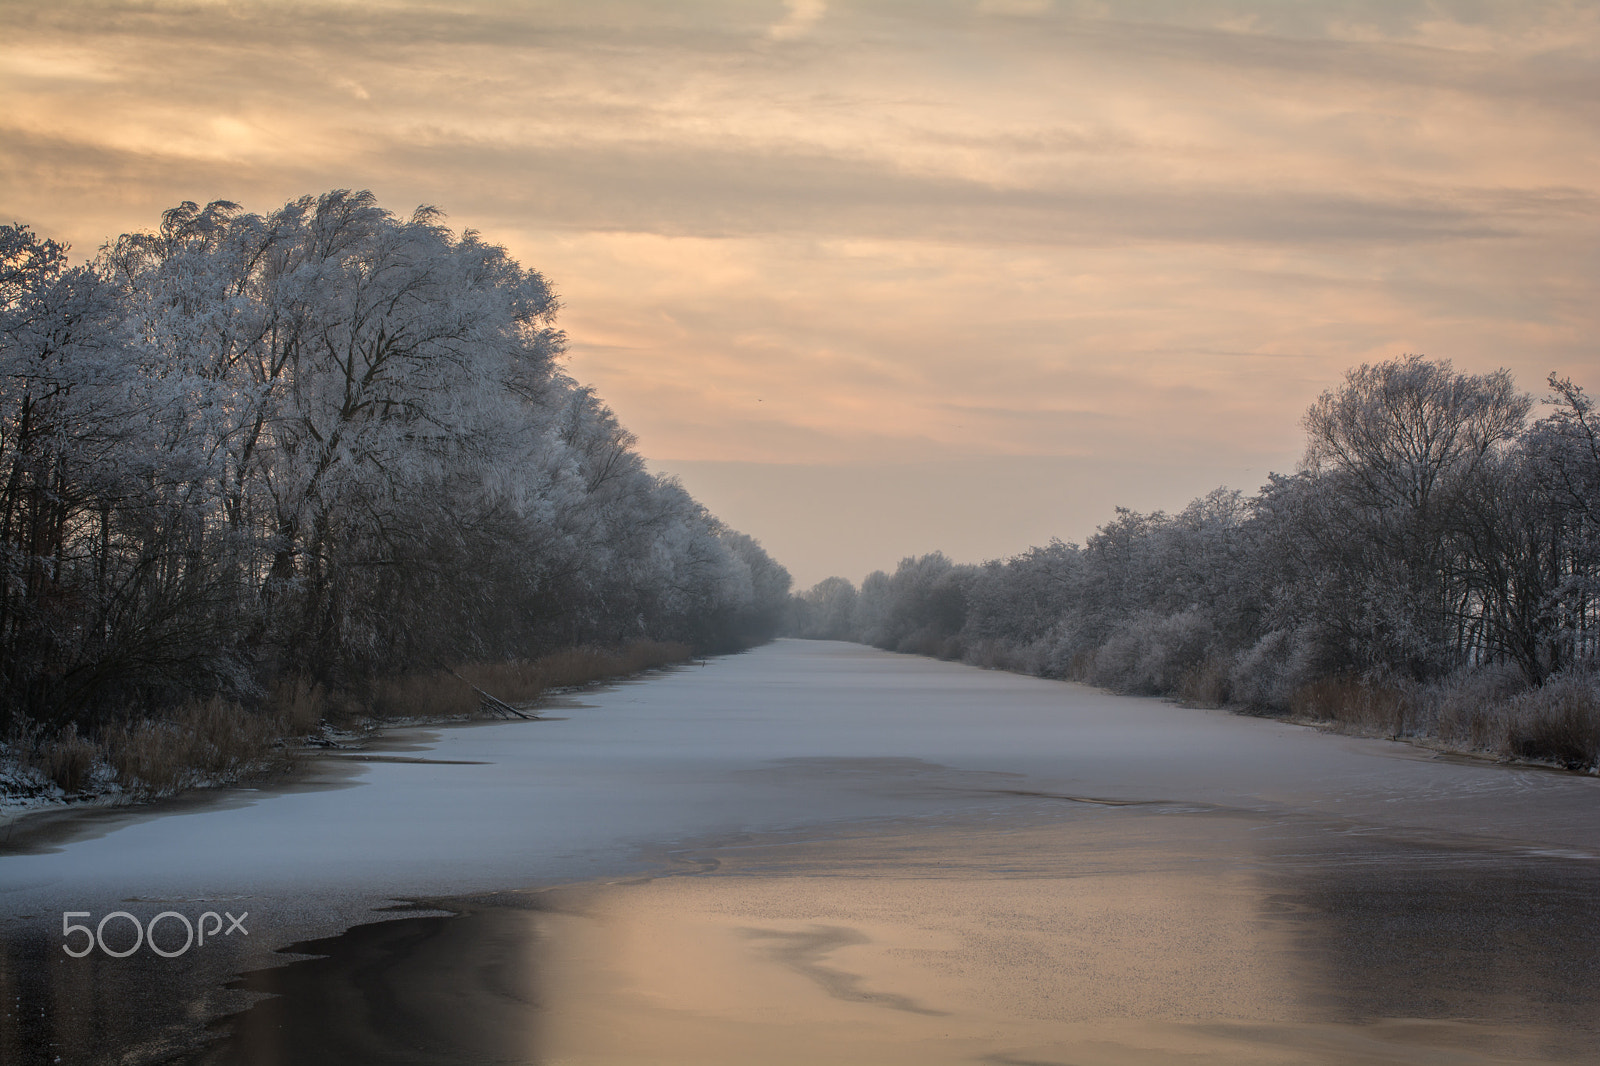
[0,226,154,717]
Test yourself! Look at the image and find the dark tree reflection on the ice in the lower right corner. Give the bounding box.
[1262,839,1600,1061]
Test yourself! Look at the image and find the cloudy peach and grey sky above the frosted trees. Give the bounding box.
[0,0,1600,587]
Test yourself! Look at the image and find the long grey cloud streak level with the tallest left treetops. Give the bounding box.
[324,138,1561,245]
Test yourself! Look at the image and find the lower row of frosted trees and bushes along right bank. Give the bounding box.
[789,357,1600,765]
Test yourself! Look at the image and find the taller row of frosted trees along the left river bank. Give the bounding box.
[0,190,789,730]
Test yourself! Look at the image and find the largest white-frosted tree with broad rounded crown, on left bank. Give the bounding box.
[106,190,560,666]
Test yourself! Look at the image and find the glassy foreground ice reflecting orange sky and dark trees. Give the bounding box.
[182,807,1600,1066]
